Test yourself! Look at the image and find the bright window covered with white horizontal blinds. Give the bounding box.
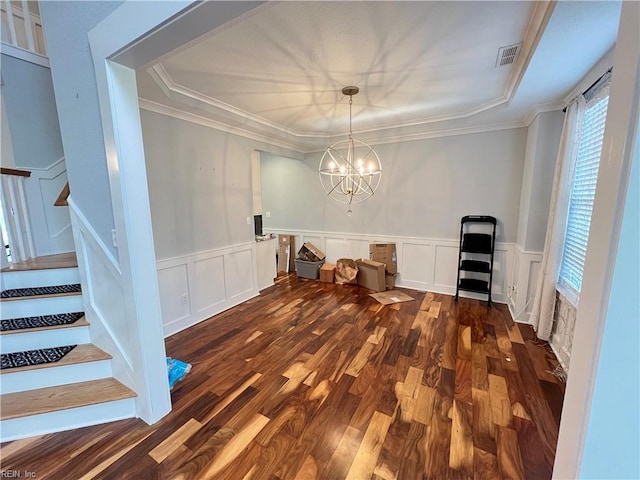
[560,87,609,293]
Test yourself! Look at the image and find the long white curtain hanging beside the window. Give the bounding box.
[531,95,585,340]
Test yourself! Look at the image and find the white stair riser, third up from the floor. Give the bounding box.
[0,326,90,356]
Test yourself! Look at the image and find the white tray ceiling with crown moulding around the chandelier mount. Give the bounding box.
[139,1,620,150]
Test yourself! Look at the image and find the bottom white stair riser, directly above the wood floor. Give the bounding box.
[0,398,136,442]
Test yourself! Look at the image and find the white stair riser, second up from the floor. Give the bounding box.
[0,360,112,394]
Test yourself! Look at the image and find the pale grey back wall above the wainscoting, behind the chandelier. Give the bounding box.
[261,128,526,242]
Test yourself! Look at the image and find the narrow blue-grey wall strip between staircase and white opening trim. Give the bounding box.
[39,1,122,257]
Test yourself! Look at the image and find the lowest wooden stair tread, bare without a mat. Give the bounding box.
[0,378,136,420]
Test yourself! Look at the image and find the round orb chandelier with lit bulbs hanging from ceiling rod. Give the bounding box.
[318,87,382,205]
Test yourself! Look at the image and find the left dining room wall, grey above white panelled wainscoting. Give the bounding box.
[141,109,296,336]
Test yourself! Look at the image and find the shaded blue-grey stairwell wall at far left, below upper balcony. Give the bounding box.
[2,54,64,170]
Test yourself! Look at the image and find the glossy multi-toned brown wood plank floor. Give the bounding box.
[0,275,564,480]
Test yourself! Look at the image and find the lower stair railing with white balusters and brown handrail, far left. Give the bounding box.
[0,168,36,262]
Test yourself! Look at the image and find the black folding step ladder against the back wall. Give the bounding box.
[456,215,497,307]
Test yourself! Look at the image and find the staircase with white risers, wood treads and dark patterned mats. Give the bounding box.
[0,254,136,442]
